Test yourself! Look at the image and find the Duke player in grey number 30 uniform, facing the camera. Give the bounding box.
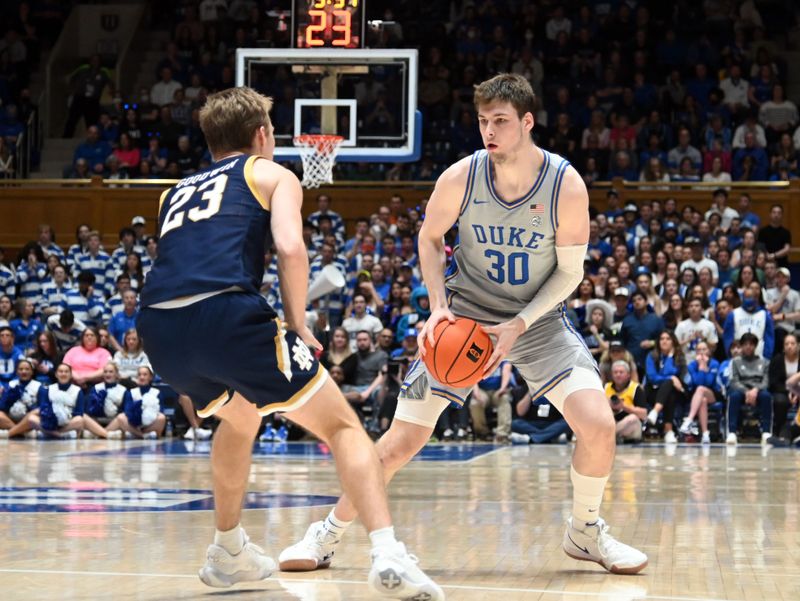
[280,74,647,574]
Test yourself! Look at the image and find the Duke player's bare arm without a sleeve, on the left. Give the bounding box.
[418,158,470,356]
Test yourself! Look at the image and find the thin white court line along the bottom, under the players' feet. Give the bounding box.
[0,568,735,601]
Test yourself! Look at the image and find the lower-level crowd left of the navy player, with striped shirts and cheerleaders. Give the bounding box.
[0,217,173,438]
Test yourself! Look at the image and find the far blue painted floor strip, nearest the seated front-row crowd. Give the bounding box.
[71,440,501,461]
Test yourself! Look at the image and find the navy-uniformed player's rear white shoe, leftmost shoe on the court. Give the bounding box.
[198,534,275,588]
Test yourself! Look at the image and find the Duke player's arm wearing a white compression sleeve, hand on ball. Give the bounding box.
[484,167,589,373]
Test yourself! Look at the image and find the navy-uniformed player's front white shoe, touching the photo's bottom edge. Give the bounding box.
[367,543,445,601]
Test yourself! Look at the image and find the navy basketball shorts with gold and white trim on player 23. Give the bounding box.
[137,292,327,417]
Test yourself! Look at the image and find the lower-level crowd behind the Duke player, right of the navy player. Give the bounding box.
[288,188,800,444]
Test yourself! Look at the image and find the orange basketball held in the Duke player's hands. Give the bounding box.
[425,317,494,388]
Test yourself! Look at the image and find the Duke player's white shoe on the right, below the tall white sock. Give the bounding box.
[563,518,647,574]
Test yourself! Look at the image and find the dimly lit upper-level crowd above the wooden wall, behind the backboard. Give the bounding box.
[61,0,800,187]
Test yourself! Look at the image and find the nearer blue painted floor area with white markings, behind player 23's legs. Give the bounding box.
[0,484,337,513]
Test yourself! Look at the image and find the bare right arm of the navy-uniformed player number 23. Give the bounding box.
[254,161,322,348]
